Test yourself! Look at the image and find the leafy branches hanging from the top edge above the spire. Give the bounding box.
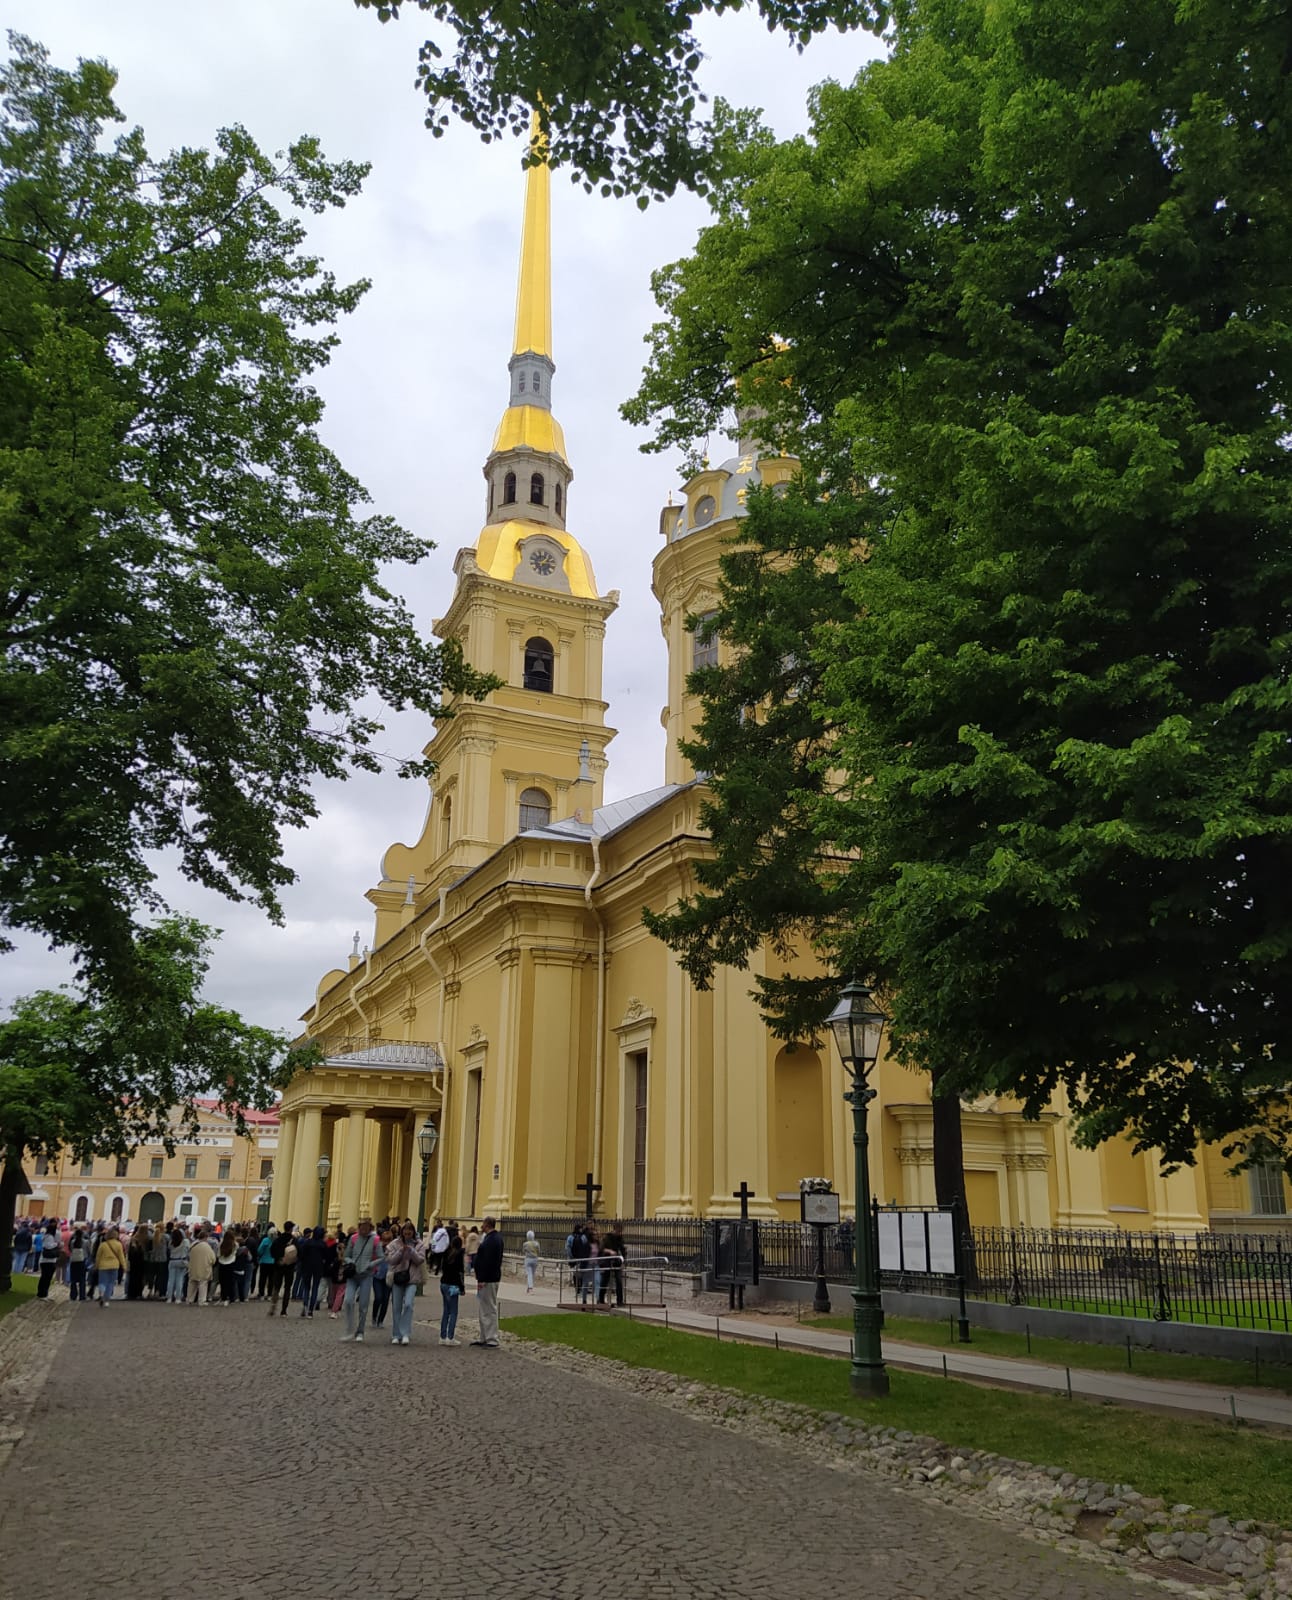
[355,0,887,206]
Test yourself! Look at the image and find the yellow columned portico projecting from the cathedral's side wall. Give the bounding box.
[273,1042,445,1227]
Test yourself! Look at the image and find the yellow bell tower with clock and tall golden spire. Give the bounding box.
[368,114,619,944]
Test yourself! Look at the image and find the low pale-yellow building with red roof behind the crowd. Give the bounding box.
[18,1101,278,1222]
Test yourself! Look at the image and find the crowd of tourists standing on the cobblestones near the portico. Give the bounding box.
[13,1218,508,1349]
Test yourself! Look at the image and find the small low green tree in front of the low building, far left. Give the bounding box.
[0,917,300,1293]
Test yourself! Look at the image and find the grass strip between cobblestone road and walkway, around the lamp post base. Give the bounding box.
[507,1314,1292,1523]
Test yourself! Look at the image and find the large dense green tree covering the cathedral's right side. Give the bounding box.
[628,0,1292,1162]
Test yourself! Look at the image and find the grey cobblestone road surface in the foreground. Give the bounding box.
[0,1301,1161,1600]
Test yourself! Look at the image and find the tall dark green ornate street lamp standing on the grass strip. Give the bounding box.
[827,978,889,1400]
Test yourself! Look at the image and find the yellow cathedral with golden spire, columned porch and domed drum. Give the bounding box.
[273,140,1289,1230]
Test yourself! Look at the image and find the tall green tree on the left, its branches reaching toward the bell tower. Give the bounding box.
[0,35,486,984]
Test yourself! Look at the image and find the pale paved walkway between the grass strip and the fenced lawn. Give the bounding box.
[504,1285,1292,1429]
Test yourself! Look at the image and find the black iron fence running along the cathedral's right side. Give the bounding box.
[500,1213,1292,1333]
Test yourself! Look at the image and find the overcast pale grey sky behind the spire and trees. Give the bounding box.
[0,0,876,1030]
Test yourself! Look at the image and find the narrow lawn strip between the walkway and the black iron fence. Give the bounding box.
[803,1315,1292,1394]
